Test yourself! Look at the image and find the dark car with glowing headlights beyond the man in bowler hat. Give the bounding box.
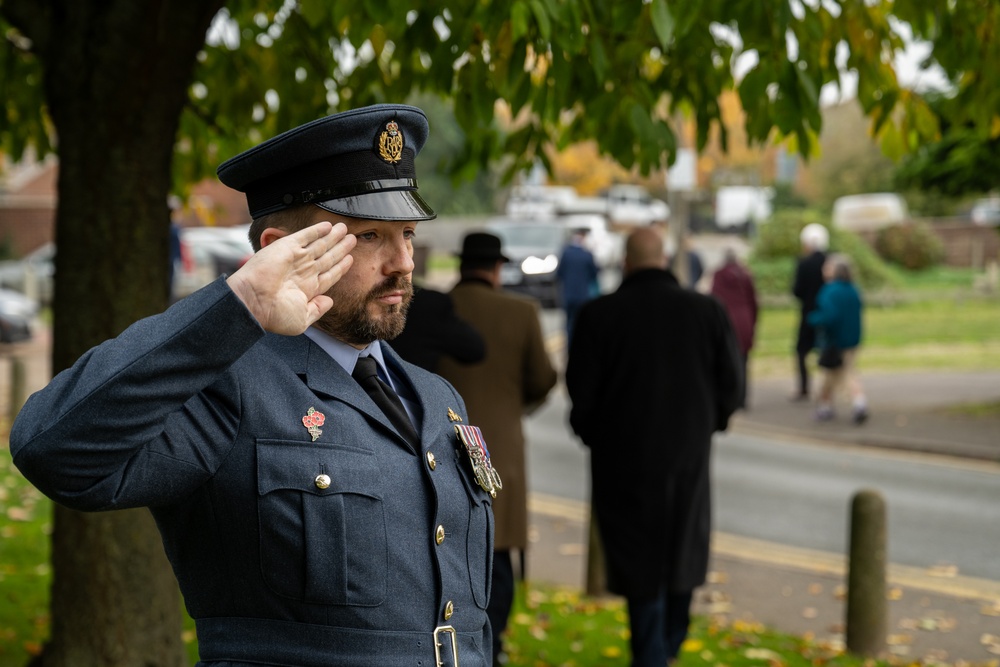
[486,218,567,308]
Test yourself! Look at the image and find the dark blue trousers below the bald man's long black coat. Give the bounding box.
[628,589,691,667]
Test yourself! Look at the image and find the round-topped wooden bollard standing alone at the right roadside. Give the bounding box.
[846,489,888,657]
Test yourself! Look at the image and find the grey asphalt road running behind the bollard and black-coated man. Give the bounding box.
[525,386,1000,581]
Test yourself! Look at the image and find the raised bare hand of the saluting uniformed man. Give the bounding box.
[226,222,357,336]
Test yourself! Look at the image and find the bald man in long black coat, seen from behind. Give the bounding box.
[566,228,741,667]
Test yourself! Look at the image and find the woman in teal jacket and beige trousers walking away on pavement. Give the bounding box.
[808,255,868,424]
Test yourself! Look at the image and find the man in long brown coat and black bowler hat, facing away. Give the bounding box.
[438,232,557,664]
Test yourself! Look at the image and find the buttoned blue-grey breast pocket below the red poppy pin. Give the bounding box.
[257,440,389,606]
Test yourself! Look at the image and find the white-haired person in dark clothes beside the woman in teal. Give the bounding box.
[791,222,830,401]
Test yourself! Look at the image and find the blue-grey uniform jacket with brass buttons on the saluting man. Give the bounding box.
[10,279,493,667]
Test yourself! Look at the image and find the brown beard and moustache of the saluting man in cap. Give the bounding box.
[316,276,413,345]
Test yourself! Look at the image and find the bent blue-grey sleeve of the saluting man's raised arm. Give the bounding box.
[10,279,264,510]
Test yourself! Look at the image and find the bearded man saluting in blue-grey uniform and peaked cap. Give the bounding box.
[10,105,496,667]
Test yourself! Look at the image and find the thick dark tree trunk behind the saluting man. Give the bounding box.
[5,0,223,667]
